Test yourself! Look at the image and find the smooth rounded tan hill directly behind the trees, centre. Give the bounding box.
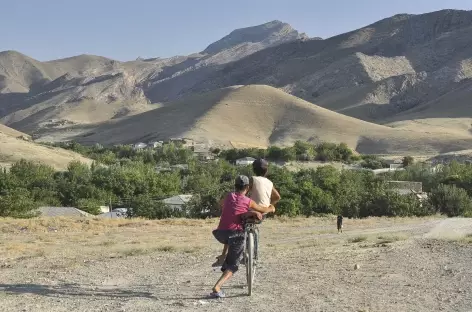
[76,85,472,153]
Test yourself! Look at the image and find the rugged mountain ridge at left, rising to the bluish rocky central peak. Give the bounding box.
[0,21,306,135]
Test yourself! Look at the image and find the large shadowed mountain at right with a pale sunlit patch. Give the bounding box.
[182,10,472,122]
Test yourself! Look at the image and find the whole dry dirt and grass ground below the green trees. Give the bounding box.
[0,217,472,312]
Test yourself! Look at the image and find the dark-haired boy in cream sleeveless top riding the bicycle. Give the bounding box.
[213,158,280,267]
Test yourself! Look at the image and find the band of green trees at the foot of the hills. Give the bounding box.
[0,142,472,219]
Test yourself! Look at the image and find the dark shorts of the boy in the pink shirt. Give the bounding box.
[213,230,244,273]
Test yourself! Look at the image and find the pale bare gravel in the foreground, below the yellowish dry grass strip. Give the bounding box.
[0,219,472,312]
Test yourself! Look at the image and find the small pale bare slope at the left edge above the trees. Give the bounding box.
[0,125,92,170]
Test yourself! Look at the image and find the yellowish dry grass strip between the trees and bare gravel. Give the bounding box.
[0,216,442,263]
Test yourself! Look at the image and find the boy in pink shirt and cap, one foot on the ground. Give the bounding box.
[210,175,275,298]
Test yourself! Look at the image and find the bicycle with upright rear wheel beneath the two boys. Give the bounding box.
[243,221,260,296]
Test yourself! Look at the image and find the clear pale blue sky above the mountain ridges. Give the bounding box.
[0,0,472,61]
